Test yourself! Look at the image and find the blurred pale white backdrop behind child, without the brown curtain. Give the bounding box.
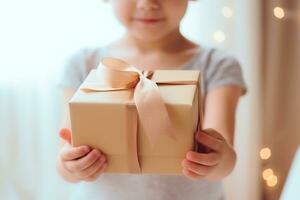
[0,0,259,200]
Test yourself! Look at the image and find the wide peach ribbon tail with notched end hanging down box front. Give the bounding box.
[134,76,176,146]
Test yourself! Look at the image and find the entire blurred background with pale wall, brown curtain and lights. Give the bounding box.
[0,0,300,200]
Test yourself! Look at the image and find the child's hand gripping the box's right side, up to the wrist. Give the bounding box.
[181,129,236,180]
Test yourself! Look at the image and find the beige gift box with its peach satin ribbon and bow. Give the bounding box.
[69,58,202,175]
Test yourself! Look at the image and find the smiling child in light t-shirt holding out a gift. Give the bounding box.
[57,0,246,200]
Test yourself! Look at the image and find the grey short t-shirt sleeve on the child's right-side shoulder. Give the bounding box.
[204,50,247,95]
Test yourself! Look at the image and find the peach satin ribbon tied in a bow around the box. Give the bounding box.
[81,58,197,173]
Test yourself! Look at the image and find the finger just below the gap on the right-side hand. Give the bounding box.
[186,151,220,166]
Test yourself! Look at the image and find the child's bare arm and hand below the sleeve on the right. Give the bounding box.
[182,86,242,180]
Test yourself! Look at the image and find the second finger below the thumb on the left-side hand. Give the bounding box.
[65,149,101,172]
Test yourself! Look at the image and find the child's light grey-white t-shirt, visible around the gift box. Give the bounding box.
[59,47,246,200]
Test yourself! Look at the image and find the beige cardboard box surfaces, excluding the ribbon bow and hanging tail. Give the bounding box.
[69,66,202,174]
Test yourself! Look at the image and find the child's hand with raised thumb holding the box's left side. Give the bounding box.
[58,128,107,182]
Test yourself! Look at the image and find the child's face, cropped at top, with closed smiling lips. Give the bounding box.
[112,0,188,41]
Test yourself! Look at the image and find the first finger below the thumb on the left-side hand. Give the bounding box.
[61,145,91,161]
